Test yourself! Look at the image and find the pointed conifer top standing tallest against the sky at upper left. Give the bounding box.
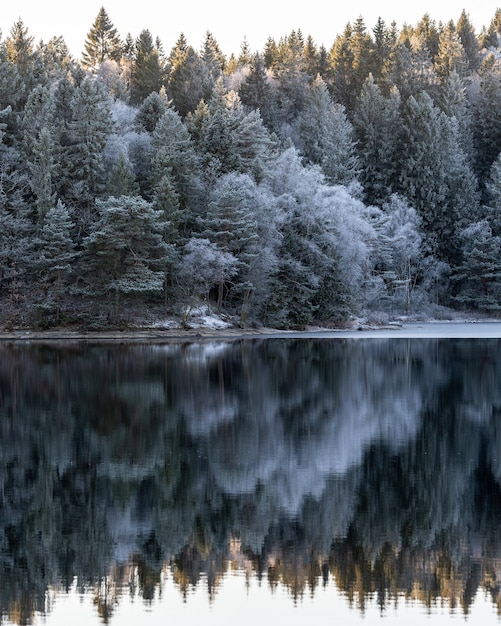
[82,7,123,73]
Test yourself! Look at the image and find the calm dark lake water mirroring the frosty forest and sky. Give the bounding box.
[0,338,501,626]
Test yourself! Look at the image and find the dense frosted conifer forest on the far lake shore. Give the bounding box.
[0,7,501,328]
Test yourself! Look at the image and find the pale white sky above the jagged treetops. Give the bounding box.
[0,0,501,58]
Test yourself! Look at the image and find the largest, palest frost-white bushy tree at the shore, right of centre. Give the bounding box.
[265,148,373,326]
